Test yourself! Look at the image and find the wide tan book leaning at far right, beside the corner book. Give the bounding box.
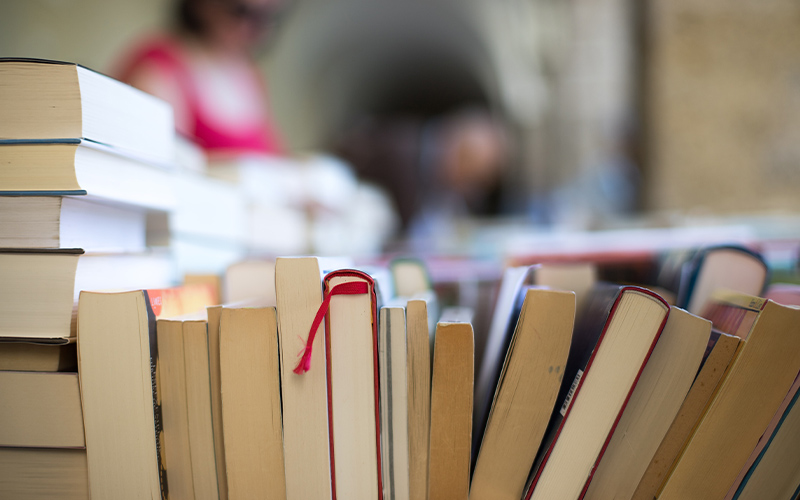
[659,301,800,500]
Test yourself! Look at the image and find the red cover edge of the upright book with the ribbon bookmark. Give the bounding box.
[323,269,383,500]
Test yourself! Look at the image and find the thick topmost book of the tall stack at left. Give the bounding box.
[0,58,175,162]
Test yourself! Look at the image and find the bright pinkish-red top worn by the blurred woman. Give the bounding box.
[118,37,284,155]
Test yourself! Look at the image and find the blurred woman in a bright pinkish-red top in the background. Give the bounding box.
[117,0,284,156]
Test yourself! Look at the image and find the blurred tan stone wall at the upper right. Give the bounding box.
[646,0,800,213]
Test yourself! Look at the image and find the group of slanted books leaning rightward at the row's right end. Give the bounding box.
[469,246,800,499]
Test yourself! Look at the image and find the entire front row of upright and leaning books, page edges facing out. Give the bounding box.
[3,243,800,499]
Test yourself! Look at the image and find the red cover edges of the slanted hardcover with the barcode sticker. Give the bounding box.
[525,286,670,500]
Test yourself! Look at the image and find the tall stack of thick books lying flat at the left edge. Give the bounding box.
[0,59,181,498]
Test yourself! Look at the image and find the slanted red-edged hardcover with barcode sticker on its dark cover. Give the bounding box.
[525,284,669,500]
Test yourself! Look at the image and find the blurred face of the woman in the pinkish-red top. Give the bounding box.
[198,0,281,53]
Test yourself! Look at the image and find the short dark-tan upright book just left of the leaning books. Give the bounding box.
[428,323,475,500]
